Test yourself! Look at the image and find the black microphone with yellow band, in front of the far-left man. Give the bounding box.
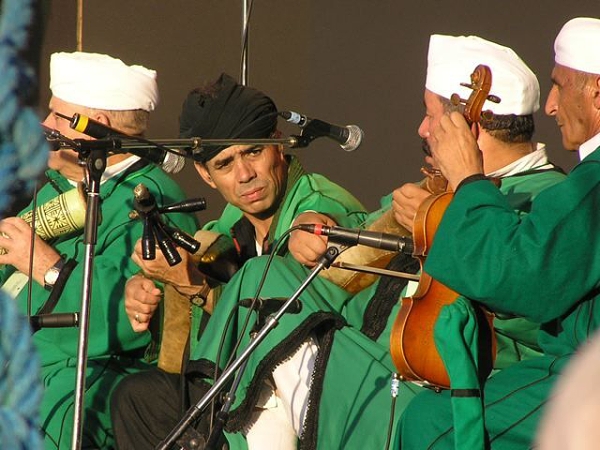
[55,113,185,173]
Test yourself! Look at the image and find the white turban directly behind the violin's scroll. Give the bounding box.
[425,34,540,115]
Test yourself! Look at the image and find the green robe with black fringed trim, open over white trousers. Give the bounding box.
[186,163,564,450]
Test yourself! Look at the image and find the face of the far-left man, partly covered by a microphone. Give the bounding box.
[42,96,89,177]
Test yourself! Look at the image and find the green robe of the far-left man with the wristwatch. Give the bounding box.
[1,165,195,449]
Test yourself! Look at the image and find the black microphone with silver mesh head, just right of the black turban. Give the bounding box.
[279,111,364,152]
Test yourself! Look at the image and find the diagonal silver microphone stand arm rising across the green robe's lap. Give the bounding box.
[155,245,344,450]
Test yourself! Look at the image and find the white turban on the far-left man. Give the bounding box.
[50,52,158,111]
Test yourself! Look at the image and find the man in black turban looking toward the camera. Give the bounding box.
[112,74,365,449]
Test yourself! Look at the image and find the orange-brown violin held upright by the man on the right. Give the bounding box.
[390,65,499,390]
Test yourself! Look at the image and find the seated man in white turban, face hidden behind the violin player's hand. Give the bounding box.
[145,36,564,449]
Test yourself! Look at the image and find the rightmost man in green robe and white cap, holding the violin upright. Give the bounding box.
[400,18,600,449]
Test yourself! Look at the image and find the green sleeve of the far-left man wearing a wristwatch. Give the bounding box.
[24,169,195,365]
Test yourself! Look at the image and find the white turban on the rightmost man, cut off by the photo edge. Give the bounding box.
[554,17,600,74]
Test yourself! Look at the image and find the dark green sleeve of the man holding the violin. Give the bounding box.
[425,159,600,322]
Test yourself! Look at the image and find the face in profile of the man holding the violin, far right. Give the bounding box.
[545,64,598,150]
